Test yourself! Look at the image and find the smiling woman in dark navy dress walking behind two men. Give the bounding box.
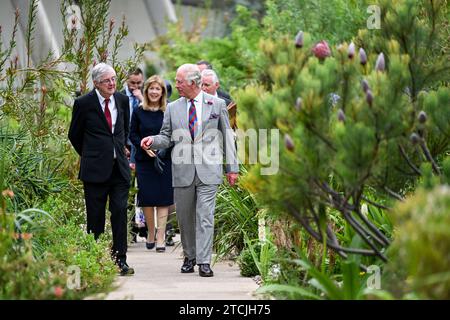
[130,75,173,252]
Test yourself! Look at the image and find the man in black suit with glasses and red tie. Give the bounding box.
[69,63,134,275]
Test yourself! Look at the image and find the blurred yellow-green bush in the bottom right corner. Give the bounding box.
[383,185,450,299]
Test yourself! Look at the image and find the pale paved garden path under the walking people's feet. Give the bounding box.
[102,237,258,300]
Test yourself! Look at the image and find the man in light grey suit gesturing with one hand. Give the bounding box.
[141,64,239,277]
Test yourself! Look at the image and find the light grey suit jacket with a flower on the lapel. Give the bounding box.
[151,92,239,187]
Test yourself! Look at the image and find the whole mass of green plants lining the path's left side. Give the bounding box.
[0,0,143,299]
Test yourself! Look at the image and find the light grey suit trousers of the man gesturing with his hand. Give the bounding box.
[174,173,218,264]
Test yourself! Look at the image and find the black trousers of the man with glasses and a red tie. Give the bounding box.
[84,163,130,261]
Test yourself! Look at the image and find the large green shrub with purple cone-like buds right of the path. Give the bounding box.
[237,0,450,261]
